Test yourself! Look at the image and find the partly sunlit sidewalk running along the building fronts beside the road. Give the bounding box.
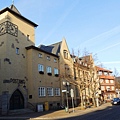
[0,103,111,120]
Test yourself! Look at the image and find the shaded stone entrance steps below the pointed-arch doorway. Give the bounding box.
[8,108,35,115]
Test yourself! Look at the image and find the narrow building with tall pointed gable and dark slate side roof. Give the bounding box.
[39,38,77,106]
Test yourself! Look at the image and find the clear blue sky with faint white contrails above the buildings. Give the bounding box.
[0,0,120,73]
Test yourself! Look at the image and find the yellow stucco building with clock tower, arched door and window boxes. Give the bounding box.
[0,5,61,114]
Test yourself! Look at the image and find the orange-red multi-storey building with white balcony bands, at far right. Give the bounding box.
[96,66,116,101]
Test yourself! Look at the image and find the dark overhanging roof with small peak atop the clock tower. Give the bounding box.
[0,5,38,27]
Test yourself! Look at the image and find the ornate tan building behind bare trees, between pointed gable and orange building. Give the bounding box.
[73,54,100,107]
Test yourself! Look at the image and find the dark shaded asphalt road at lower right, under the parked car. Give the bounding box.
[60,105,120,120]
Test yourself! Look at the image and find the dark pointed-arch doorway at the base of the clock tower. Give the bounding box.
[10,89,24,110]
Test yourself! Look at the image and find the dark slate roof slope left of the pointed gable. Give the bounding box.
[39,41,62,55]
